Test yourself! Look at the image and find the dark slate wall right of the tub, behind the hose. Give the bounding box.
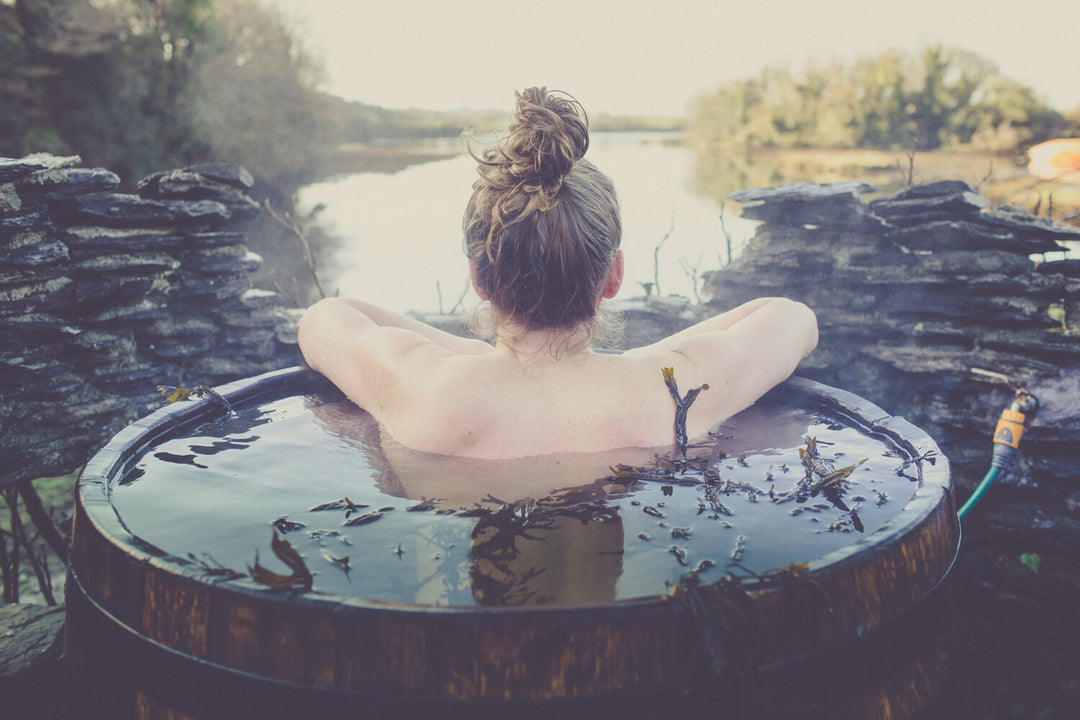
[705,181,1080,717]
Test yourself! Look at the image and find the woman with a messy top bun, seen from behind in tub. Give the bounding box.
[299,87,818,459]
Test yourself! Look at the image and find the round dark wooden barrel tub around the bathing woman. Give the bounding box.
[65,368,962,720]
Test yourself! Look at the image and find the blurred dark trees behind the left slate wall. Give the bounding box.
[0,0,327,194]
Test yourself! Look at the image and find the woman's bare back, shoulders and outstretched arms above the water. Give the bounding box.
[300,298,816,458]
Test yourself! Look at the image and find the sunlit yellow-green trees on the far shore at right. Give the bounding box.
[687,45,1069,150]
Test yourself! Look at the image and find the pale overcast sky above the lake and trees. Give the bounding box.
[268,0,1080,116]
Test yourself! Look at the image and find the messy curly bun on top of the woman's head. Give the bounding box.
[502,87,589,192]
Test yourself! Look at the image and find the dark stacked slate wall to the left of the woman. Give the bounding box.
[0,154,298,483]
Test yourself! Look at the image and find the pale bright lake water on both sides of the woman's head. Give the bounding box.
[297,133,757,312]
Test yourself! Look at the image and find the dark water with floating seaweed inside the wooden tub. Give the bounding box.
[111,397,916,606]
